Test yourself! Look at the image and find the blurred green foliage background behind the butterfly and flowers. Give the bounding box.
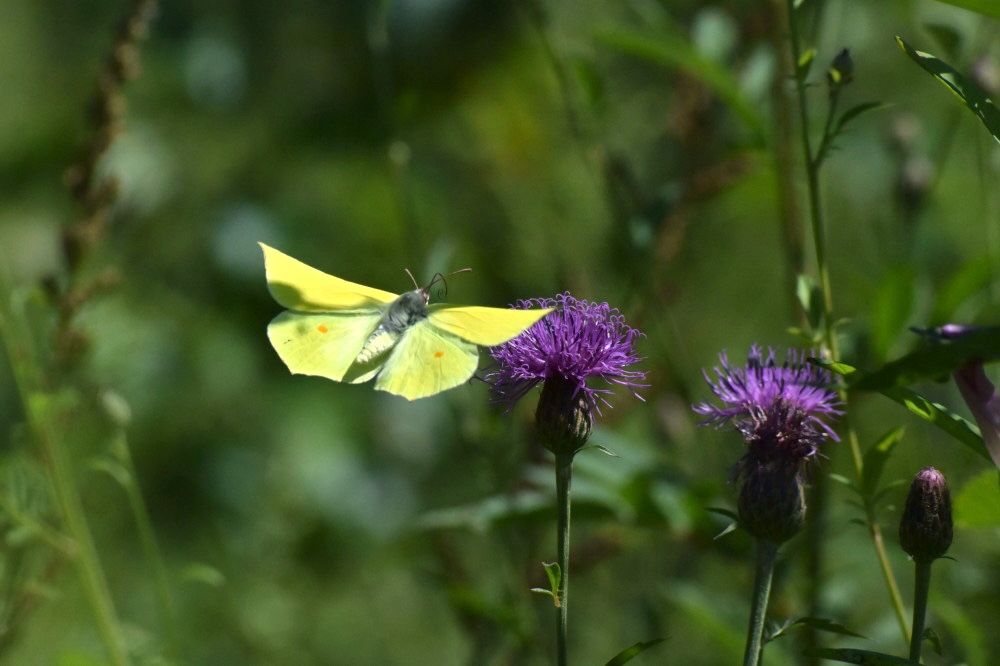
[0,0,1000,665]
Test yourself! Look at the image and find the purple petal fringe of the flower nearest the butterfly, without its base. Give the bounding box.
[486,292,648,413]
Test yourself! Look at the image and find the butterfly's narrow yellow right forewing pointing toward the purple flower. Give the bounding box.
[427,303,552,347]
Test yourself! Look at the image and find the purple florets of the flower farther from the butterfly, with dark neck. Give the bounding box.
[692,345,842,475]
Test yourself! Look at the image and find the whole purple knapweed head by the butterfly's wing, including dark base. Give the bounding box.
[486,293,646,451]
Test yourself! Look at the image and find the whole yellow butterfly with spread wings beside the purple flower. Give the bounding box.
[260,243,551,400]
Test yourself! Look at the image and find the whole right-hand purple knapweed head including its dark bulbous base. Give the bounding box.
[692,345,841,543]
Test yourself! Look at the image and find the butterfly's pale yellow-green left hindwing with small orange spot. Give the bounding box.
[267,311,382,384]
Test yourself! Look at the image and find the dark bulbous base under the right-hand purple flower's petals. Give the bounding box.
[738,460,806,544]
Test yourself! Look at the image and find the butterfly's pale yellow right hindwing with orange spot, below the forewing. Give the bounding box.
[375,319,479,400]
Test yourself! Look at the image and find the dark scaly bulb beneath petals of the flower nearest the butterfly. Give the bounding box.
[535,376,594,454]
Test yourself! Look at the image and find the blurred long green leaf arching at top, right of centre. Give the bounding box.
[595,26,766,146]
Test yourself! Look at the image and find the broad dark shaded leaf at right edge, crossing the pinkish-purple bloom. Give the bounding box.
[850,326,1000,391]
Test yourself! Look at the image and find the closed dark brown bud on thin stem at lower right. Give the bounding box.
[899,467,954,562]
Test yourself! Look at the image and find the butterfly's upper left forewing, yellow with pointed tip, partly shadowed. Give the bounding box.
[260,243,396,312]
